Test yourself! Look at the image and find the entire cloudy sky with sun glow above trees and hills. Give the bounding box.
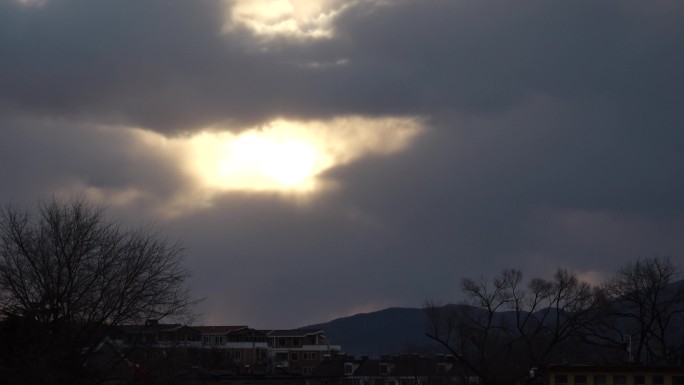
[0,0,684,328]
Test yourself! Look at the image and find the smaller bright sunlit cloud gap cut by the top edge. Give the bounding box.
[226,0,353,38]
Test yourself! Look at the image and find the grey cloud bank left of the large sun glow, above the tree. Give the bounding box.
[0,118,187,204]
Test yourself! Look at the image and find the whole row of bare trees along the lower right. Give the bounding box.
[424,257,684,385]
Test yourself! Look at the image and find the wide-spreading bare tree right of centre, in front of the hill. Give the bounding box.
[424,269,596,384]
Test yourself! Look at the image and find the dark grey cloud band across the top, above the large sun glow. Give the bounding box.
[0,0,684,131]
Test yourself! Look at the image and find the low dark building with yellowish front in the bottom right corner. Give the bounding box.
[546,364,684,385]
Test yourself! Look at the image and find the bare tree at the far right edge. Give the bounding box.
[603,257,684,365]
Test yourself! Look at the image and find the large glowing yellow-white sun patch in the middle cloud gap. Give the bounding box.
[123,116,423,211]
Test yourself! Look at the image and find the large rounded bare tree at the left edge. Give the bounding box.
[0,199,191,383]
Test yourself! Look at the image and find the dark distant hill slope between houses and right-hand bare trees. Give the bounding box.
[307,308,452,356]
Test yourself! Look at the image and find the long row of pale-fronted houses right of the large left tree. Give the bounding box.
[110,320,341,378]
